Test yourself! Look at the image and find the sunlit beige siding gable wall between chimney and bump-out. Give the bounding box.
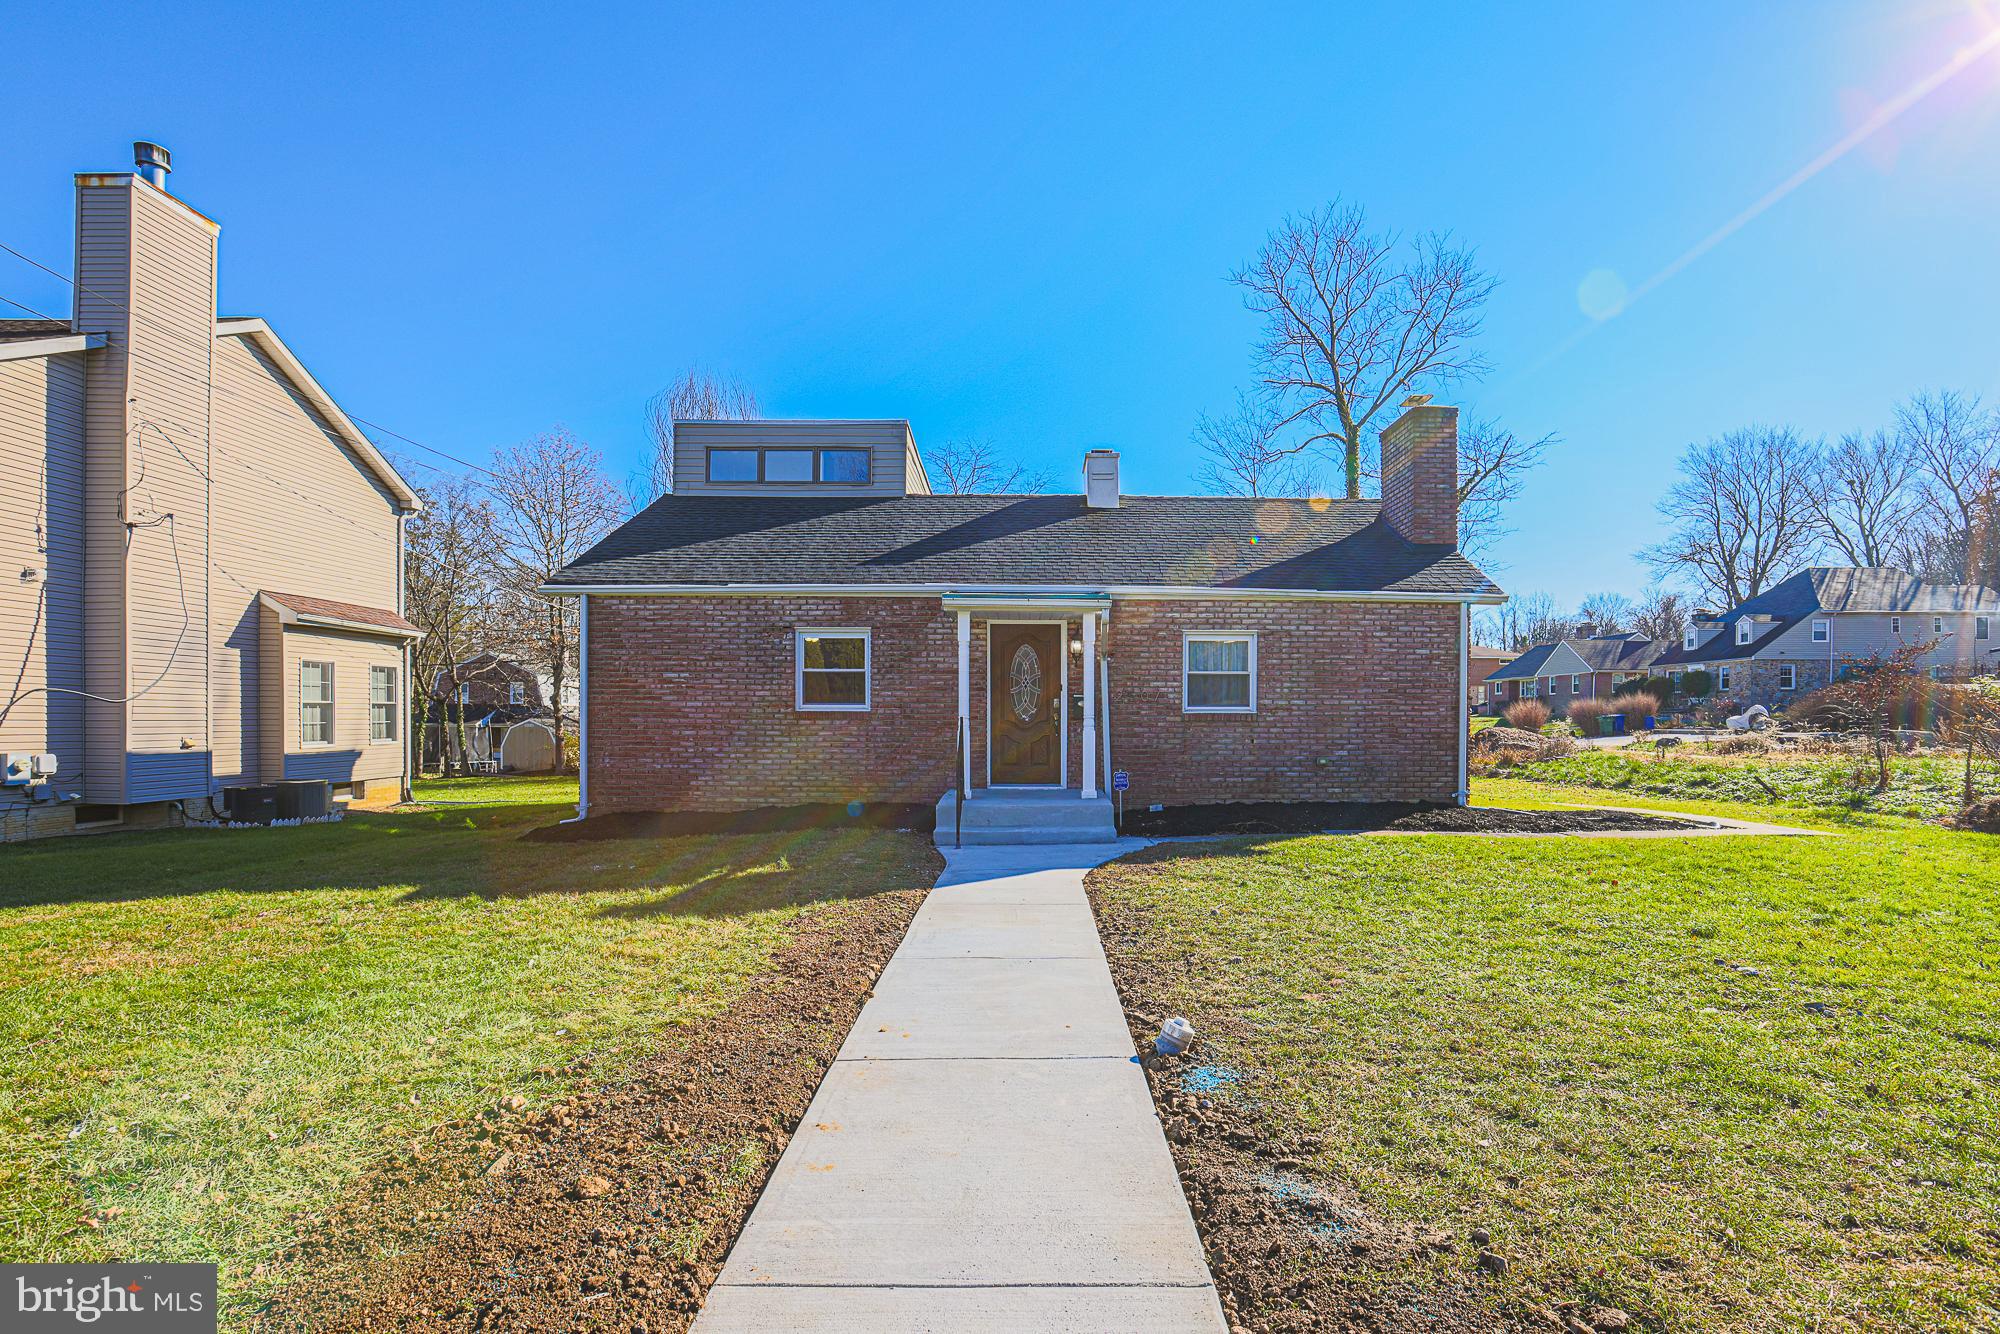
[210,336,400,784]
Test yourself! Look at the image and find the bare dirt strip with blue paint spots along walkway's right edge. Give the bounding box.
[1084,876,1528,1334]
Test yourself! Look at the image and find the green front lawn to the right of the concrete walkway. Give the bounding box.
[1094,780,2000,1330]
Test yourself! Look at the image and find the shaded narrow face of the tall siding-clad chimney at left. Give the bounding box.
[76,176,132,804]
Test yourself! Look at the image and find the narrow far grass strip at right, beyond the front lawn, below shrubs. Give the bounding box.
[1506,742,2000,818]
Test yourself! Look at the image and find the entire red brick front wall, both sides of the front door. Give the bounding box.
[588,596,1458,812]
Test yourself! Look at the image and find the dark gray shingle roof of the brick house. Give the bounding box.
[552,496,1500,596]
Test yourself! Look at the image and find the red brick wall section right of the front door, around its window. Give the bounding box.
[1110,600,1460,810]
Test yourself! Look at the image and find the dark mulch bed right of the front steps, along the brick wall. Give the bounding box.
[1120,802,1708,838]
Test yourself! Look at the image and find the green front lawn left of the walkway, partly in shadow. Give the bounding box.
[0,778,932,1302]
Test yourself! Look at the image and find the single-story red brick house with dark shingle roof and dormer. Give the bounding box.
[544,404,1502,836]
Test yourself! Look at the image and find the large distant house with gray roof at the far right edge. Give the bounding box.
[1654,566,2000,708]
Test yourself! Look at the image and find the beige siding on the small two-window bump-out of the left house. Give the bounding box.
[260,632,410,782]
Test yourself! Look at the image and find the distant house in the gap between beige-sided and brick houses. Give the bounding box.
[424,654,562,774]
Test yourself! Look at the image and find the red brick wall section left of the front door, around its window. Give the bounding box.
[588,596,958,812]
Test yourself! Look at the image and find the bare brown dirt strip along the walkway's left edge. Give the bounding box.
[260,854,934,1334]
